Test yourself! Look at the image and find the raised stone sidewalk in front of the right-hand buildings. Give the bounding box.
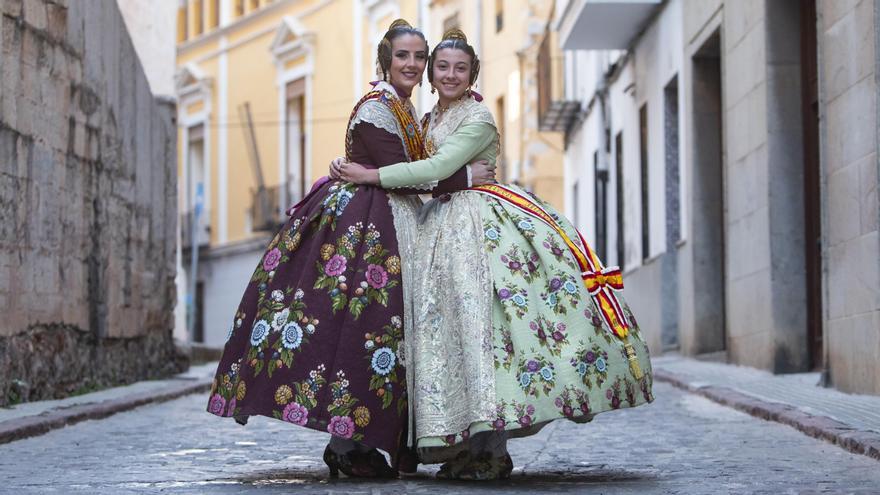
[652,355,880,462]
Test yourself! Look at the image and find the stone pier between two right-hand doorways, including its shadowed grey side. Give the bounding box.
[722,0,809,372]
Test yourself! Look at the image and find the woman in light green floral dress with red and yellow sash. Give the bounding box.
[331,30,653,479]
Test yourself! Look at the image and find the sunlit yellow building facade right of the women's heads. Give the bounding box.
[426,0,564,210]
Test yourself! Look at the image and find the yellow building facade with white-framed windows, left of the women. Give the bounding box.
[176,0,424,347]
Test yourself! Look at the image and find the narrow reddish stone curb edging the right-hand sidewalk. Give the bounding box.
[654,368,880,461]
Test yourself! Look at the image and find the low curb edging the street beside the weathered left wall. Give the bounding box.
[0,378,212,444]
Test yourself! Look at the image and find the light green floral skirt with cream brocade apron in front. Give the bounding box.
[407,186,653,463]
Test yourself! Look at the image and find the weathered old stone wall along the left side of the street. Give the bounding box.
[0,0,186,405]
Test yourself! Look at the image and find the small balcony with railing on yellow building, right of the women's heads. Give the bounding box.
[537,26,580,131]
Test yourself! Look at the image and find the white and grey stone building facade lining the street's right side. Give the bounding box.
[553,0,880,394]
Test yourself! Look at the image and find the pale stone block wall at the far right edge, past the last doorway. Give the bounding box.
[818,0,880,394]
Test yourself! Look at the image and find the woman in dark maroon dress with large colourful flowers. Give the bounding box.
[208,20,488,477]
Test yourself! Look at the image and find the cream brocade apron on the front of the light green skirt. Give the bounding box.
[410,193,496,462]
